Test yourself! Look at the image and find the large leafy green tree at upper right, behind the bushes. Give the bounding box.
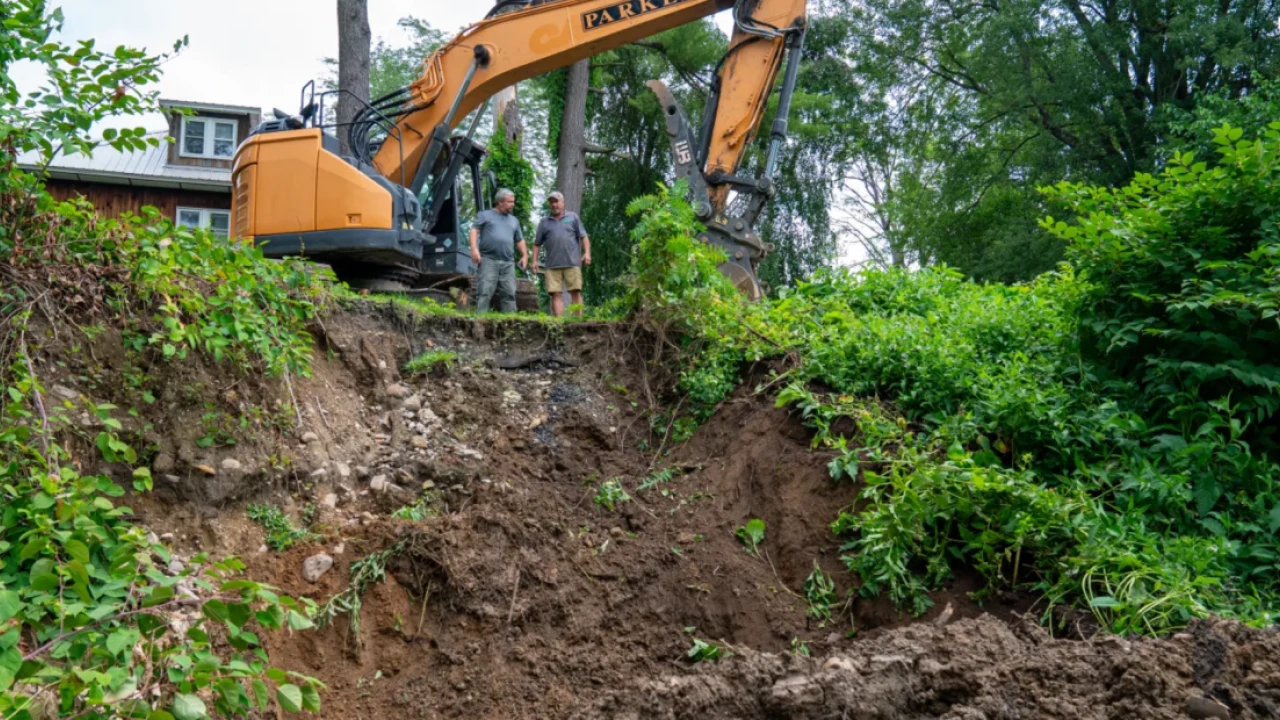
[847,0,1280,279]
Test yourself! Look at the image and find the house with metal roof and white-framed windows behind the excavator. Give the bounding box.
[19,100,261,237]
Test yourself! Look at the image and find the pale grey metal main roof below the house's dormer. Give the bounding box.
[18,132,232,192]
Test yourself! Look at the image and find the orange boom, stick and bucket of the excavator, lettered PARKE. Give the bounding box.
[352,0,806,296]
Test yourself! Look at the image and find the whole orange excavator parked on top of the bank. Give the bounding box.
[232,0,806,299]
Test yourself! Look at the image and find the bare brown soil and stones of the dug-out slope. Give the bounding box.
[30,301,1280,720]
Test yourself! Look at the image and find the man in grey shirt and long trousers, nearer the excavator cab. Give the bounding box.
[471,188,529,313]
